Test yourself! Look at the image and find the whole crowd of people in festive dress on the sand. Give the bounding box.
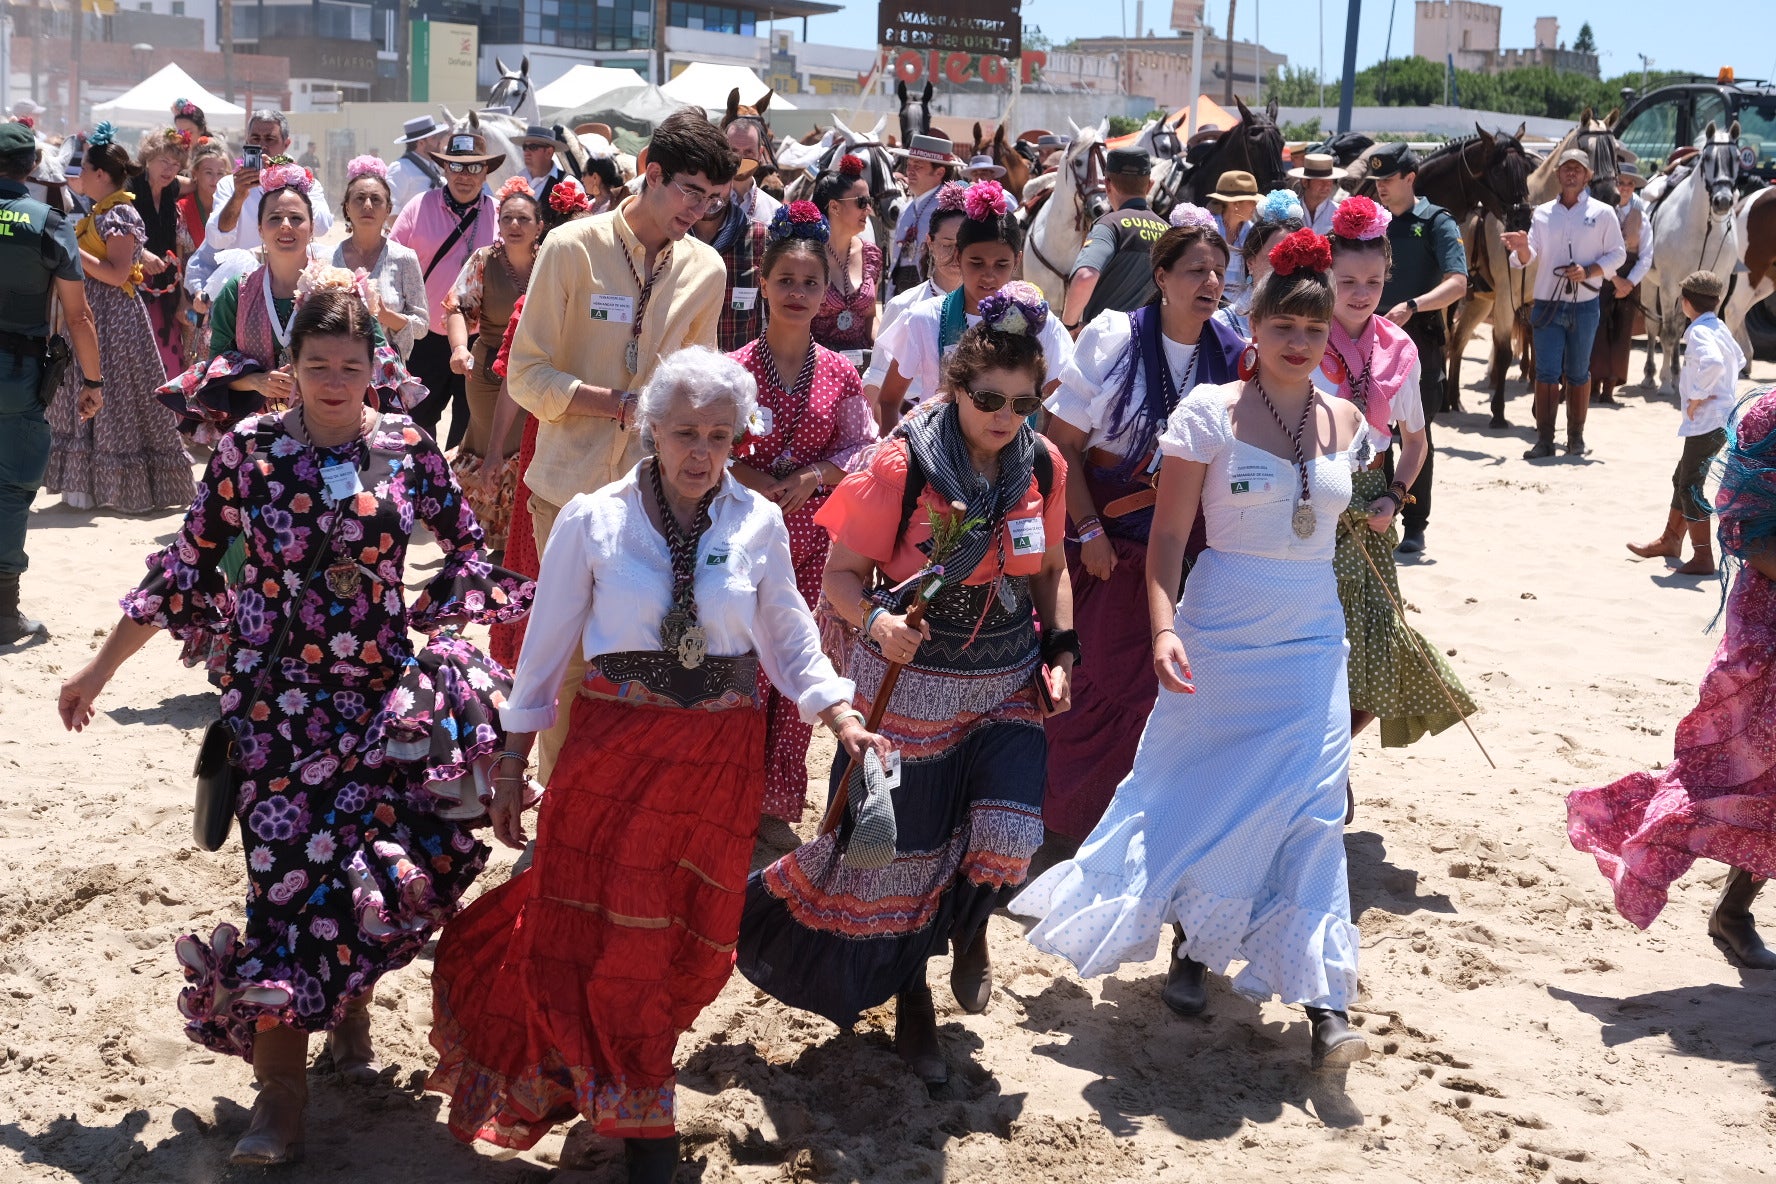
[0,94,1776,1184]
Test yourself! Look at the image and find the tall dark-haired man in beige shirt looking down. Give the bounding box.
[508,108,739,781]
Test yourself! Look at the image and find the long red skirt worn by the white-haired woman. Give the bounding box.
[426,696,765,1148]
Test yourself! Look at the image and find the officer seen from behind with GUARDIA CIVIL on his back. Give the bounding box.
[1060,147,1172,334]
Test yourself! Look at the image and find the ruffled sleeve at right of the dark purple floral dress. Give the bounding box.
[403,419,536,632]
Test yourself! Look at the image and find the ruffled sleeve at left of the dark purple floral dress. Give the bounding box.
[121,421,258,641]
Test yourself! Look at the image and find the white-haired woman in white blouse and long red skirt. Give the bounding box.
[428,346,890,1182]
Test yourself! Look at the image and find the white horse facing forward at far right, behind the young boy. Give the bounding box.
[1641,119,1751,396]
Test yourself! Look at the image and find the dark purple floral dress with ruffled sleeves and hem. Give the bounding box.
[123,415,535,1058]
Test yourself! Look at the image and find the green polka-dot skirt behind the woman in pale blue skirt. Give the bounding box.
[1332,469,1474,747]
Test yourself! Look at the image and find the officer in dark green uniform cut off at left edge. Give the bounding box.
[0,122,103,644]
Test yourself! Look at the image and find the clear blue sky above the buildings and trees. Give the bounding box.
[808,0,1776,78]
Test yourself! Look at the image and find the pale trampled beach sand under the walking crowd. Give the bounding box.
[0,335,1776,1184]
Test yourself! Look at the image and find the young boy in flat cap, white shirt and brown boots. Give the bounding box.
[1629,272,1746,575]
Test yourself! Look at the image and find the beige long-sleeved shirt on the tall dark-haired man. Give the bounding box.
[506,197,728,506]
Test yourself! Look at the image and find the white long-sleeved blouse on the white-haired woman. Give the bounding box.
[499,462,854,731]
